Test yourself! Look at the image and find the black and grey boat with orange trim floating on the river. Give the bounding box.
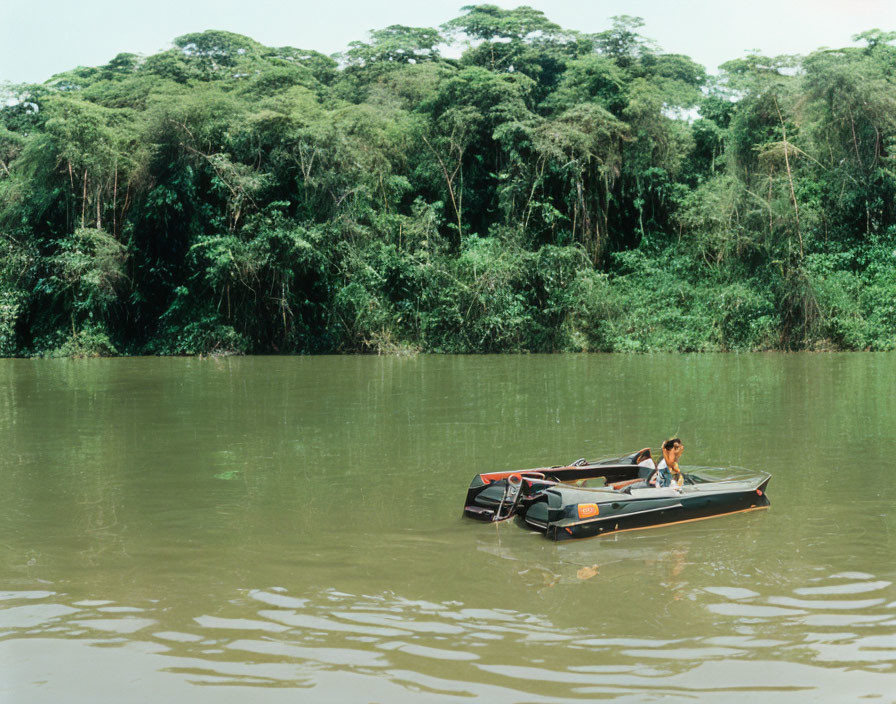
[464,448,771,540]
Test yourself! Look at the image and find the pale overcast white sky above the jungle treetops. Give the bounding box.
[0,0,896,83]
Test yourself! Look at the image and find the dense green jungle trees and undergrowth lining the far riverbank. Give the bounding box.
[0,5,896,356]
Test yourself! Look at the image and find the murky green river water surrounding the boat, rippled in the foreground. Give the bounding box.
[0,353,896,704]
